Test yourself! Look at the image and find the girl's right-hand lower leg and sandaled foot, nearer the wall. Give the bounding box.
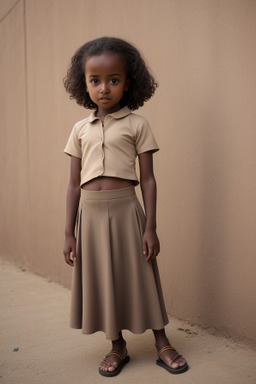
[153,328,188,373]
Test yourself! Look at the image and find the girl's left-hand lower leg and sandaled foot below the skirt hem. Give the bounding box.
[99,332,130,376]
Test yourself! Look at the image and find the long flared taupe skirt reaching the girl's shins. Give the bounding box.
[71,187,168,340]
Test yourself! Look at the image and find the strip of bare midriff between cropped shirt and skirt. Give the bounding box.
[82,176,135,191]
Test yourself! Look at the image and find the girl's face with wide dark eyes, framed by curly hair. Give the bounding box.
[85,52,129,116]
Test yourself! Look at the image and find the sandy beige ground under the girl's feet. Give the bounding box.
[0,260,256,384]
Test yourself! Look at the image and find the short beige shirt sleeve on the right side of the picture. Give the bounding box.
[135,118,159,155]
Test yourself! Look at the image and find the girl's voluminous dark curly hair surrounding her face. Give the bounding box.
[64,37,158,110]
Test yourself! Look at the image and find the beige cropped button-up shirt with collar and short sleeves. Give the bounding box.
[64,107,159,186]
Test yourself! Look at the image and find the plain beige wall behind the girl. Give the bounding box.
[0,0,256,343]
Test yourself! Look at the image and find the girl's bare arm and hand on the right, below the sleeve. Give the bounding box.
[139,152,160,261]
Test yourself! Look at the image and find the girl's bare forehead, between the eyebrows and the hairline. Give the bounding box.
[85,52,125,73]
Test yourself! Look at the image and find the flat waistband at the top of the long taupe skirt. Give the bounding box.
[81,186,135,200]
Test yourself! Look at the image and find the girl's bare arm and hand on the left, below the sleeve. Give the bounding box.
[63,156,81,266]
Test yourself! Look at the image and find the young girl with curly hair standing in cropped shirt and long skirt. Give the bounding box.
[63,37,188,376]
